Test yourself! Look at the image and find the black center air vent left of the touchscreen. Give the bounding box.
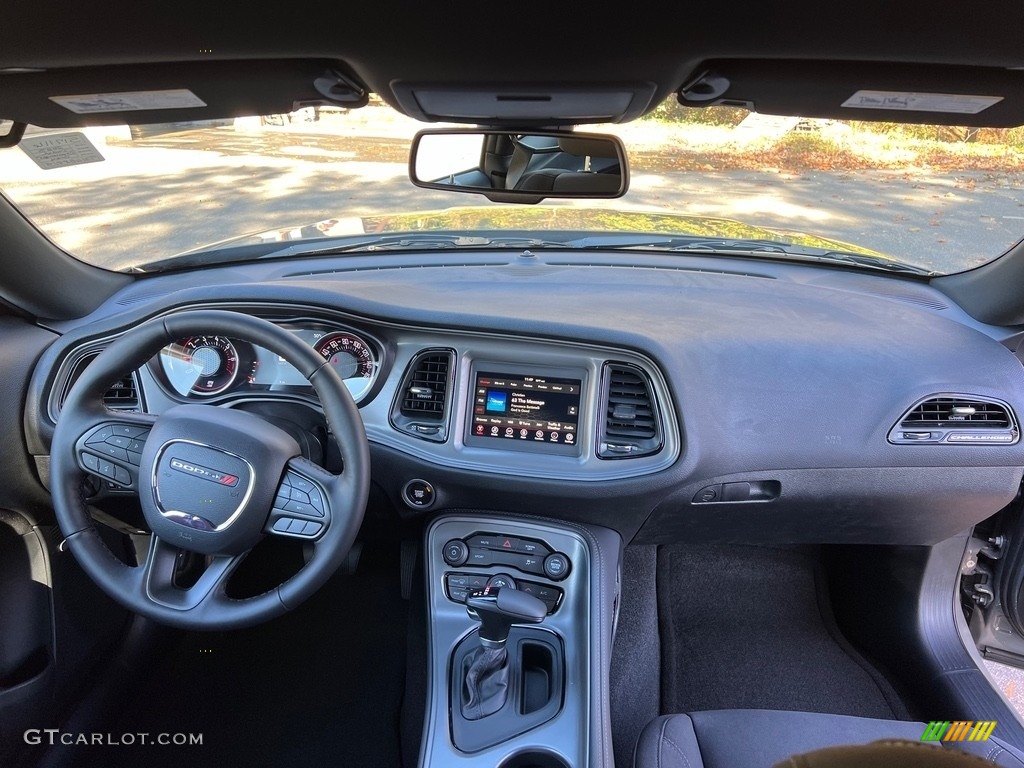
[391,349,455,442]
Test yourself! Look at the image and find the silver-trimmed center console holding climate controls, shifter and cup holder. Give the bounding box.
[420,518,622,768]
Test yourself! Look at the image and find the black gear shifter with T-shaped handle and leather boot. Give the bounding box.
[462,587,548,720]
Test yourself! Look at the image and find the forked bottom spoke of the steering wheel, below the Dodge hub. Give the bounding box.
[137,536,246,612]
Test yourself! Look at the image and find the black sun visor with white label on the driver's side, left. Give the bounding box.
[0,59,368,128]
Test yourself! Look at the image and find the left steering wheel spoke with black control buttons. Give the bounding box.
[75,414,156,490]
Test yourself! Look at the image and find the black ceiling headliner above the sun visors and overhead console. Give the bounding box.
[0,0,1024,124]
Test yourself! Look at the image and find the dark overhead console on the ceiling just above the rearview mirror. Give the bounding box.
[391,81,655,126]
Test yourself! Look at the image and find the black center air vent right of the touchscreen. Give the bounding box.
[597,362,664,459]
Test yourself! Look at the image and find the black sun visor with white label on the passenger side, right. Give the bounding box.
[679,59,1024,128]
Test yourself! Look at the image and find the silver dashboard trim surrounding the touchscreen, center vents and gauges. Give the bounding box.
[54,302,683,482]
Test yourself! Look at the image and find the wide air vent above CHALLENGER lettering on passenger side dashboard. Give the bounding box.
[889,394,1020,445]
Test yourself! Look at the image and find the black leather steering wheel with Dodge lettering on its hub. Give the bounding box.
[50,310,370,630]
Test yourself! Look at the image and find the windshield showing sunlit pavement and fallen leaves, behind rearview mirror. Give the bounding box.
[0,101,1024,273]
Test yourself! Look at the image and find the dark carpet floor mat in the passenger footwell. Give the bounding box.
[657,545,906,719]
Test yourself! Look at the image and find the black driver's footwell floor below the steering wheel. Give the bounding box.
[92,548,408,768]
